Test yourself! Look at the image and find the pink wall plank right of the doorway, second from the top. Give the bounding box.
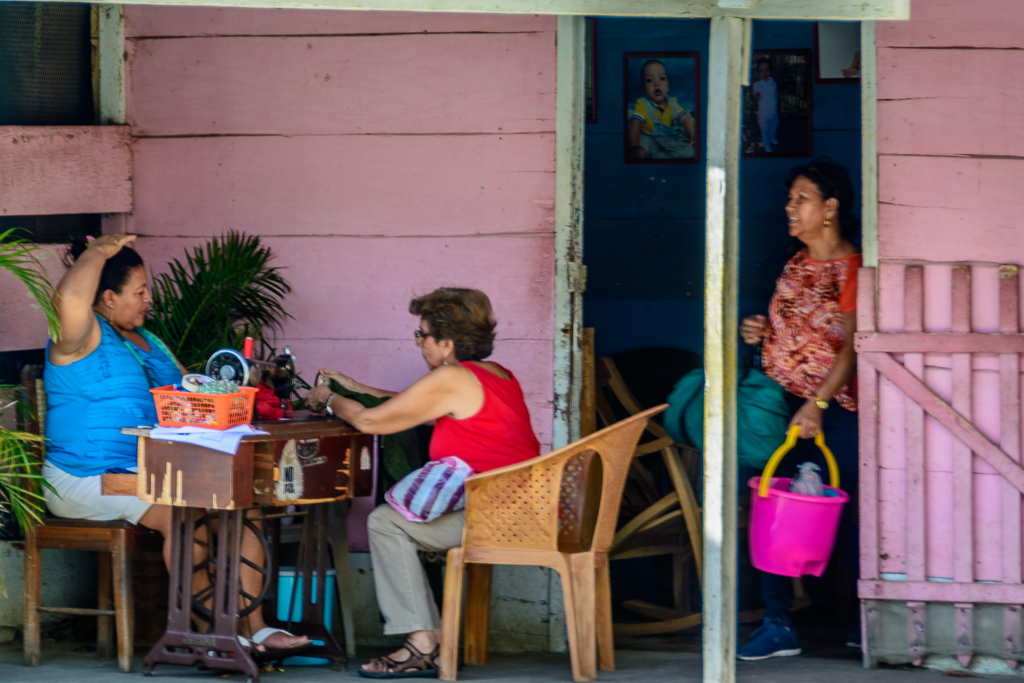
[878,47,1024,156]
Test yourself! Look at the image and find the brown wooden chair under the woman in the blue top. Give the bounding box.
[20,366,163,673]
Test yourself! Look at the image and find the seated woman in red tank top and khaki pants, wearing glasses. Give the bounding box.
[306,288,541,678]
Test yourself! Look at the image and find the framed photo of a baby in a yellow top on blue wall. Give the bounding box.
[623,52,700,164]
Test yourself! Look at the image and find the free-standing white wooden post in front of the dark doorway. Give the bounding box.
[703,16,750,683]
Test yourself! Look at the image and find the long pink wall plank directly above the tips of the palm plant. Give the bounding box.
[133,133,554,237]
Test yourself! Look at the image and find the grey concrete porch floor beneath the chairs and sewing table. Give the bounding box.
[0,640,966,683]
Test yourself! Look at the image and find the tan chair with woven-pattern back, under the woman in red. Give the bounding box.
[440,405,667,681]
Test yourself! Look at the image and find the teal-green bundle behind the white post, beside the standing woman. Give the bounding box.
[665,368,791,469]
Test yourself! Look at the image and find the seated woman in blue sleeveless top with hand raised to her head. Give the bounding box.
[43,234,307,649]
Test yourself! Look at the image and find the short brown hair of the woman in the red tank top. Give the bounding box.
[409,287,497,360]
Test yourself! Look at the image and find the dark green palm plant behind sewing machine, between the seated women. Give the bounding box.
[146,231,292,372]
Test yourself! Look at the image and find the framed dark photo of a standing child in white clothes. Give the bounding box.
[742,49,813,158]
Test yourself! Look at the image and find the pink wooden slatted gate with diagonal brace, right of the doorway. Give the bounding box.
[856,263,1024,667]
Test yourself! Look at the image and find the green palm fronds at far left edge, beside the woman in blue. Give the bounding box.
[0,228,60,596]
